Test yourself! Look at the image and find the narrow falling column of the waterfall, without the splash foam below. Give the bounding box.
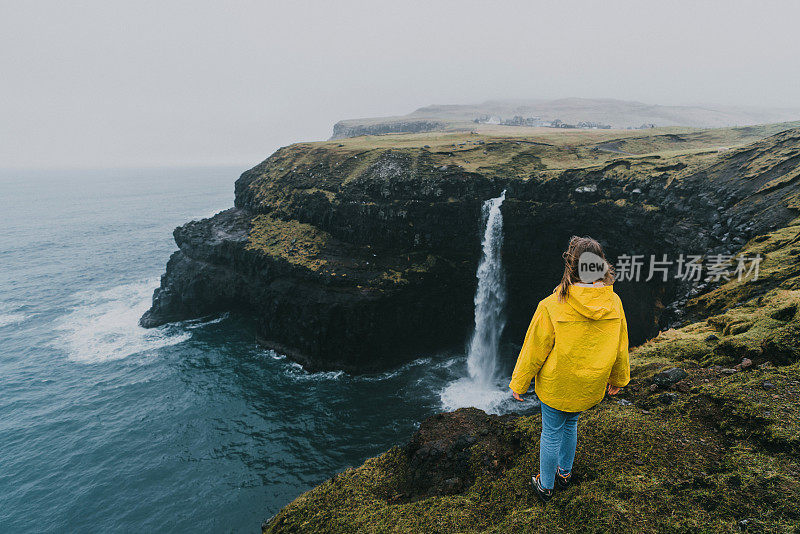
[467,191,506,385]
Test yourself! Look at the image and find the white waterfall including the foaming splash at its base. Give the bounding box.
[441,191,510,412]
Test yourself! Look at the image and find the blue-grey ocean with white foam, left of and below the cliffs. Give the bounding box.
[0,168,532,532]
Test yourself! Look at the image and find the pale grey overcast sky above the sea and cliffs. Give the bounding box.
[0,0,800,168]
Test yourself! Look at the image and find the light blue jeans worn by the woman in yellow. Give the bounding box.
[539,401,581,489]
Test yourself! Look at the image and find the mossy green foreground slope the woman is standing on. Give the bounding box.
[265,290,800,532]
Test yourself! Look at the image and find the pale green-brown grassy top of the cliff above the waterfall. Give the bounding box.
[241,123,796,218]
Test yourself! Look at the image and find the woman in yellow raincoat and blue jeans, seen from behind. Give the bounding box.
[509,237,630,502]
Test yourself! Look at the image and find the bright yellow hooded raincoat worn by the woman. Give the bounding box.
[509,285,630,412]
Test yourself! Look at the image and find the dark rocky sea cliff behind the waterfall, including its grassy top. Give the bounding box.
[141,130,800,371]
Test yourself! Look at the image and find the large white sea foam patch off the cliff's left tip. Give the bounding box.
[54,280,192,363]
